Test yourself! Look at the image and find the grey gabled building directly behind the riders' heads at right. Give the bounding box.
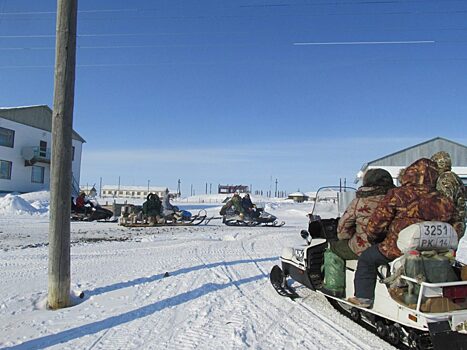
[355,137,467,186]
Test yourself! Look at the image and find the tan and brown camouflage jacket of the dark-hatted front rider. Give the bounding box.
[337,187,384,255]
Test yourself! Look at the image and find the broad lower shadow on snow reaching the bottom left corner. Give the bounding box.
[3,274,265,350]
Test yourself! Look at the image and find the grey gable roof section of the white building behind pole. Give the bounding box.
[0,105,86,142]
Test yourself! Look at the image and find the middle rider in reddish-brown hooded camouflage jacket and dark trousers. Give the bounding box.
[348,158,454,308]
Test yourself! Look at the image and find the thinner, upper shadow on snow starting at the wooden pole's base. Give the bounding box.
[84,257,278,299]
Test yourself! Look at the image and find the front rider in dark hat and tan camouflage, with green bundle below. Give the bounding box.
[322,169,395,297]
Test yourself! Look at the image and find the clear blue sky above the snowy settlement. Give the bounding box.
[0,0,467,194]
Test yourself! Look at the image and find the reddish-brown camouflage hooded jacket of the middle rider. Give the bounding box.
[366,158,454,259]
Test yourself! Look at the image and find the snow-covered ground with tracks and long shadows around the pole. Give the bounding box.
[0,193,392,350]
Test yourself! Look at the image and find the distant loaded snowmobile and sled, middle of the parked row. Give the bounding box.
[118,204,211,227]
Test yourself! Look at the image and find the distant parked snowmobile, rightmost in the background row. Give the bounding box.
[222,207,285,227]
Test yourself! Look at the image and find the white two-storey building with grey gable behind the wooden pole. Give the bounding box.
[0,105,85,192]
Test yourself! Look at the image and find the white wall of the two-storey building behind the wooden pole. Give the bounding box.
[0,117,82,192]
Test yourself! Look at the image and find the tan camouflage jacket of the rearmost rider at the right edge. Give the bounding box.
[436,171,466,239]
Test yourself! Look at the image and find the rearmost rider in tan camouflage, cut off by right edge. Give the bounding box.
[431,151,466,239]
